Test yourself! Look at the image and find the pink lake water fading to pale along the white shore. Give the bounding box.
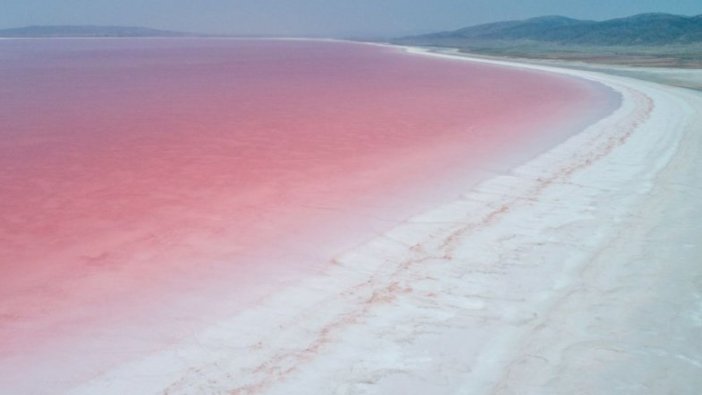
[0,40,615,389]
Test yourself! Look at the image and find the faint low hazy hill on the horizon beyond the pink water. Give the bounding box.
[0,26,193,38]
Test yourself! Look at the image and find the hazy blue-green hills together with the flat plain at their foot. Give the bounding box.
[398,14,702,68]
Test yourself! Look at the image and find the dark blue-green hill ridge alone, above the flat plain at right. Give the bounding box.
[396,14,702,46]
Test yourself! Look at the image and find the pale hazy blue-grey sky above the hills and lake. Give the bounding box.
[0,0,702,36]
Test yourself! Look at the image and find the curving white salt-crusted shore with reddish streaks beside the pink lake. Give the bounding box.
[63,50,702,394]
